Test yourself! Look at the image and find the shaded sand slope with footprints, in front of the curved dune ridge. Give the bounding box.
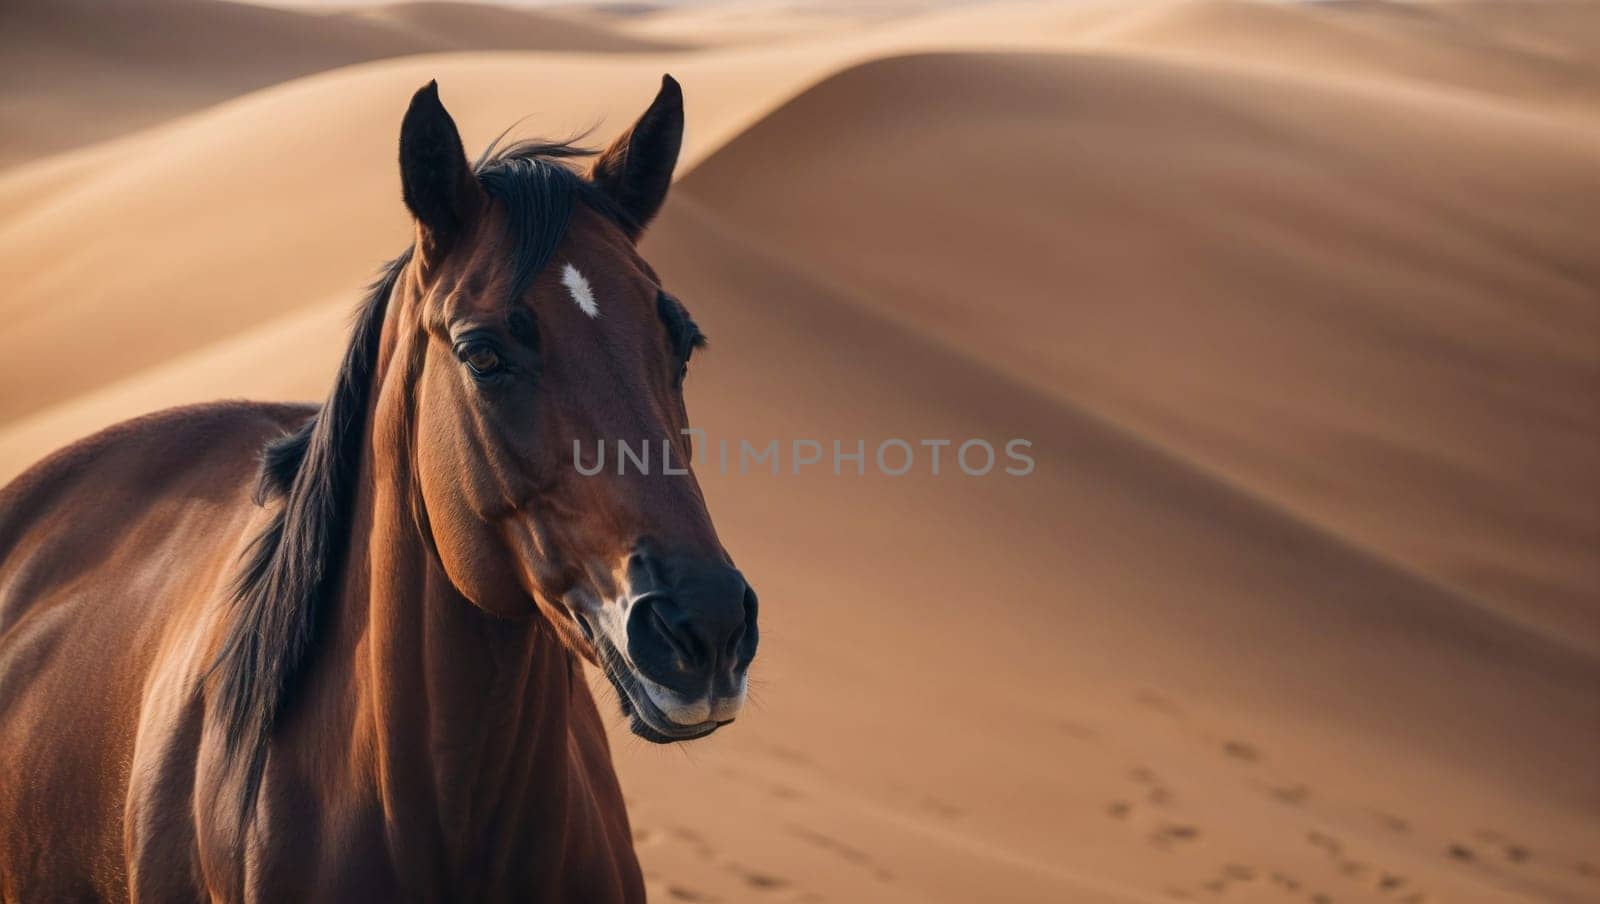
[624,187,1597,901]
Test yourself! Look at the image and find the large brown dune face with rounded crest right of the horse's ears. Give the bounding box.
[685,54,1600,653]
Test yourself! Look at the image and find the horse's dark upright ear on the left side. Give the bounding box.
[400,82,483,256]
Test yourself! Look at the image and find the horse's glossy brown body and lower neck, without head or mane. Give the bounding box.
[0,403,643,902]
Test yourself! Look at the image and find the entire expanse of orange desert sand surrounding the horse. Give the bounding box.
[0,0,1600,904]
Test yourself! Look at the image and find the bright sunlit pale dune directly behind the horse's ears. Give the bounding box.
[0,56,864,418]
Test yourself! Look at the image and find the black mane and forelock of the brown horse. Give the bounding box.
[211,141,611,814]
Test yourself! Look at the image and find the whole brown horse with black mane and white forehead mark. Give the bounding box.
[0,77,757,902]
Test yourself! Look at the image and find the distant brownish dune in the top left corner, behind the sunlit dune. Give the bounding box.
[0,0,667,166]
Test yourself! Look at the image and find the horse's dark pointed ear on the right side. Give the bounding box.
[589,75,683,238]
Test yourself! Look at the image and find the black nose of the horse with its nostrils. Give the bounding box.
[629,566,758,683]
